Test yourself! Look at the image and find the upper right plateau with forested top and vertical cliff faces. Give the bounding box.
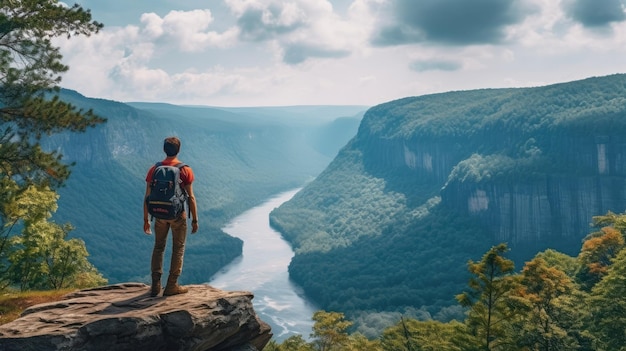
[356,75,626,254]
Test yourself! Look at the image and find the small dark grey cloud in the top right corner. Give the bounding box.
[562,0,626,28]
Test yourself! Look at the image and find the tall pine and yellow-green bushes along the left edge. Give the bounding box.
[0,0,105,290]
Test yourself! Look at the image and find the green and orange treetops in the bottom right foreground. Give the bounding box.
[265,212,626,351]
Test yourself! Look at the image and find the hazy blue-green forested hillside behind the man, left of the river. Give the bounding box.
[43,91,365,284]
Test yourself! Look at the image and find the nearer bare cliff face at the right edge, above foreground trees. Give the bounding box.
[442,136,626,254]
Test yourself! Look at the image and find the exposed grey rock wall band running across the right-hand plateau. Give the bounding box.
[358,132,626,254]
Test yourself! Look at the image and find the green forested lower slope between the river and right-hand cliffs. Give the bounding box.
[270,142,491,327]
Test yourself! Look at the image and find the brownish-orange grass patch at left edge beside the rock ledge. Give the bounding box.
[0,289,75,325]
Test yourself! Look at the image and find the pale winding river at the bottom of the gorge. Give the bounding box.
[208,189,317,342]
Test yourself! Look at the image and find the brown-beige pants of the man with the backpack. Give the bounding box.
[151,213,187,277]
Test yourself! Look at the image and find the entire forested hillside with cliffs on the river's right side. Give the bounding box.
[271,75,626,330]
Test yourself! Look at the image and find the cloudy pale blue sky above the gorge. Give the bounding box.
[55,0,626,107]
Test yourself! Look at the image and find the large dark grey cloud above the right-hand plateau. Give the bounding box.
[372,0,537,46]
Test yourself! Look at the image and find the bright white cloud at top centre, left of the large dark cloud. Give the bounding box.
[226,0,370,65]
